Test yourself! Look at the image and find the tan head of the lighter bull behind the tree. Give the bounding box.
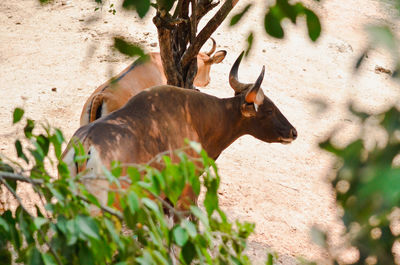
[193,38,226,87]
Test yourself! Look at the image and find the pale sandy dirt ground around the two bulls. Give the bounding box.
[0,0,399,265]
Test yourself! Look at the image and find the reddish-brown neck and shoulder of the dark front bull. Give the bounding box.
[191,94,246,159]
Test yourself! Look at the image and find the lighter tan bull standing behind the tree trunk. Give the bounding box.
[80,38,226,126]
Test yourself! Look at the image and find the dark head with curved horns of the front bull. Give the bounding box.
[229,52,297,143]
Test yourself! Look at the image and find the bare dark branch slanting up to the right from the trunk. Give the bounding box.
[181,0,238,69]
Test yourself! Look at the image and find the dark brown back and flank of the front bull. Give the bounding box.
[74,86,199,167]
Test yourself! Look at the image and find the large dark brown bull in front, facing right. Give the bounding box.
[64,53,297,212]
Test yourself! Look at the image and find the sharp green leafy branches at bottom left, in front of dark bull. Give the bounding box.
[0,109,264,265]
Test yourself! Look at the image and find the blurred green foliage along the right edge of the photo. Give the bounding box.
[315,1,400,264]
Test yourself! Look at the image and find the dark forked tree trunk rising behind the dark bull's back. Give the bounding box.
[153,0,238,89]
